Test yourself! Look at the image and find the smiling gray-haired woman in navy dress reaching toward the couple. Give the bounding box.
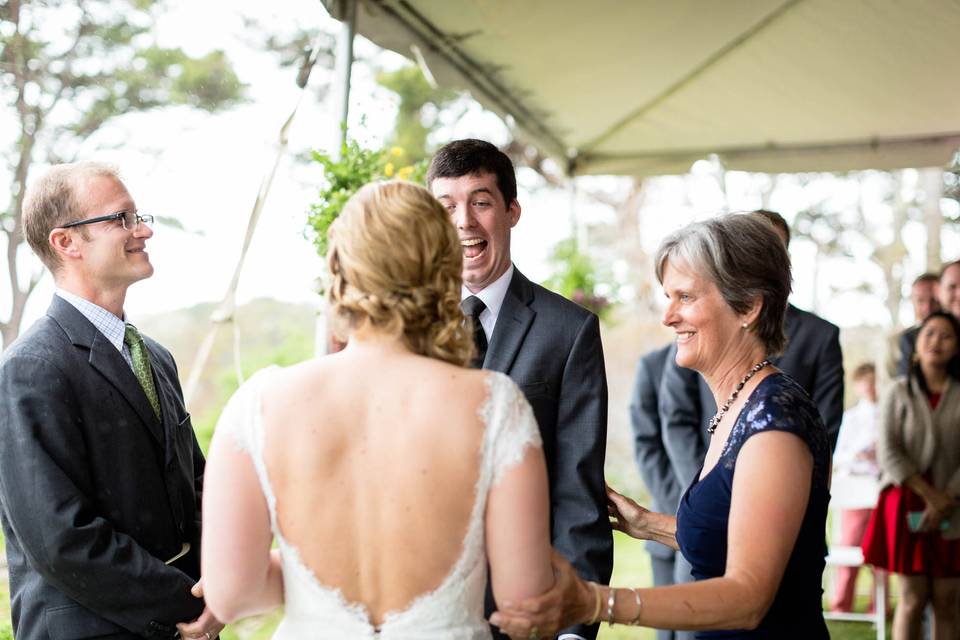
[493,214,830,639]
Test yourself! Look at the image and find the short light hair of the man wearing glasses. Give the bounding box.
[22,162,120,272]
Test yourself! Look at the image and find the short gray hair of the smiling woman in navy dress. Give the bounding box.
[655,213,791,356]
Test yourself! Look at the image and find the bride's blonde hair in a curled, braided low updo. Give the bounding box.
[327,181,474,365]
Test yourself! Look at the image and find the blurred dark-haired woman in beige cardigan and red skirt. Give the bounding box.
[863,312,960,640]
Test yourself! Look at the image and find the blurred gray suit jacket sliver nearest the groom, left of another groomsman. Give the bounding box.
[630,345,682,558]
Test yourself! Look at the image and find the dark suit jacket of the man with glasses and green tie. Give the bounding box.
[0,296,204,640]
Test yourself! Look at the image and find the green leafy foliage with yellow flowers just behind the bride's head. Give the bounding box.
[307,140,427,256]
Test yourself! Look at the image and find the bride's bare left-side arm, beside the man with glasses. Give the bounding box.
[201,432,283,622]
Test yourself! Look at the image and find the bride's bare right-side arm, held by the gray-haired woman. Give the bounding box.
[485,446,553,605]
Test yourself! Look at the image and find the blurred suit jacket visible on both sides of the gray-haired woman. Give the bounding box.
[660,304,843,487]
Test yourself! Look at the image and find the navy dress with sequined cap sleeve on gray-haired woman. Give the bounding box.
[677,373,830,640]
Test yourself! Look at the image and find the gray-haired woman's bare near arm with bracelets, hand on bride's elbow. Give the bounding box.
[491,431,813,638]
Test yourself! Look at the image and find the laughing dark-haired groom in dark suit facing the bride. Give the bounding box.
[427,140,613,640]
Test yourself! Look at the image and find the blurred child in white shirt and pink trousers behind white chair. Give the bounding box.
[830,362,880,612]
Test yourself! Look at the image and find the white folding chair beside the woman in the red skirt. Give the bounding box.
[823,476,887,640]
